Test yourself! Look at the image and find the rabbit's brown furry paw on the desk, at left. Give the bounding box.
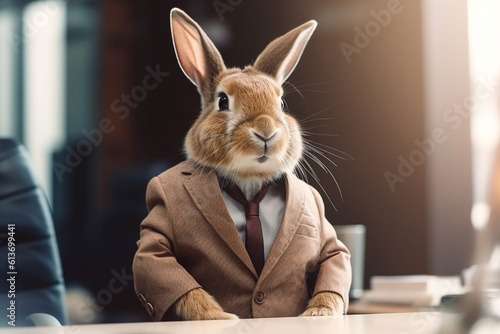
[175,289,238,320]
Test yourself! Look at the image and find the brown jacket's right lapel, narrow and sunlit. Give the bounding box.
[259,173,305,280]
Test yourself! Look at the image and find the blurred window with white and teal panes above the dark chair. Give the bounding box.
[0,0,66,204]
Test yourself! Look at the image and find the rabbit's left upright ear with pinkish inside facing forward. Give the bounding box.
[170,8,226,97]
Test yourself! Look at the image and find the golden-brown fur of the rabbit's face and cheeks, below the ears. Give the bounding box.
[185,70,302,185]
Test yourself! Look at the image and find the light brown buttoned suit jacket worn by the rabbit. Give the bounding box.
[133,162,351,320]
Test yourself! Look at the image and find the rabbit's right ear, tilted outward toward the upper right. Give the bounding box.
[254,20,318,85]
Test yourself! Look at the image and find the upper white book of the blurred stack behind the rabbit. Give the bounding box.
[370,275,462,295]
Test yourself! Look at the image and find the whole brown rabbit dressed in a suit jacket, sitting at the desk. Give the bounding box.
[133,8,351,320]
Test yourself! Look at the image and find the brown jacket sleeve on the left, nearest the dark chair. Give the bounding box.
[132,178,200,321]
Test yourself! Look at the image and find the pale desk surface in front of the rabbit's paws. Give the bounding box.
[1,312,450,334]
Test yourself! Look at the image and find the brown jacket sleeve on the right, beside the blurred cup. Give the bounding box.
[312,188,352,314]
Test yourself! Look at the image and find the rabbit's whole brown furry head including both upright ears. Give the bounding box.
[171,8,317,187]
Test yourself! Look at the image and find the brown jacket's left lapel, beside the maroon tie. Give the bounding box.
[182,162,257,277]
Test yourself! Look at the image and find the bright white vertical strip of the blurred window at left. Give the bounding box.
[23,1,66,204]
